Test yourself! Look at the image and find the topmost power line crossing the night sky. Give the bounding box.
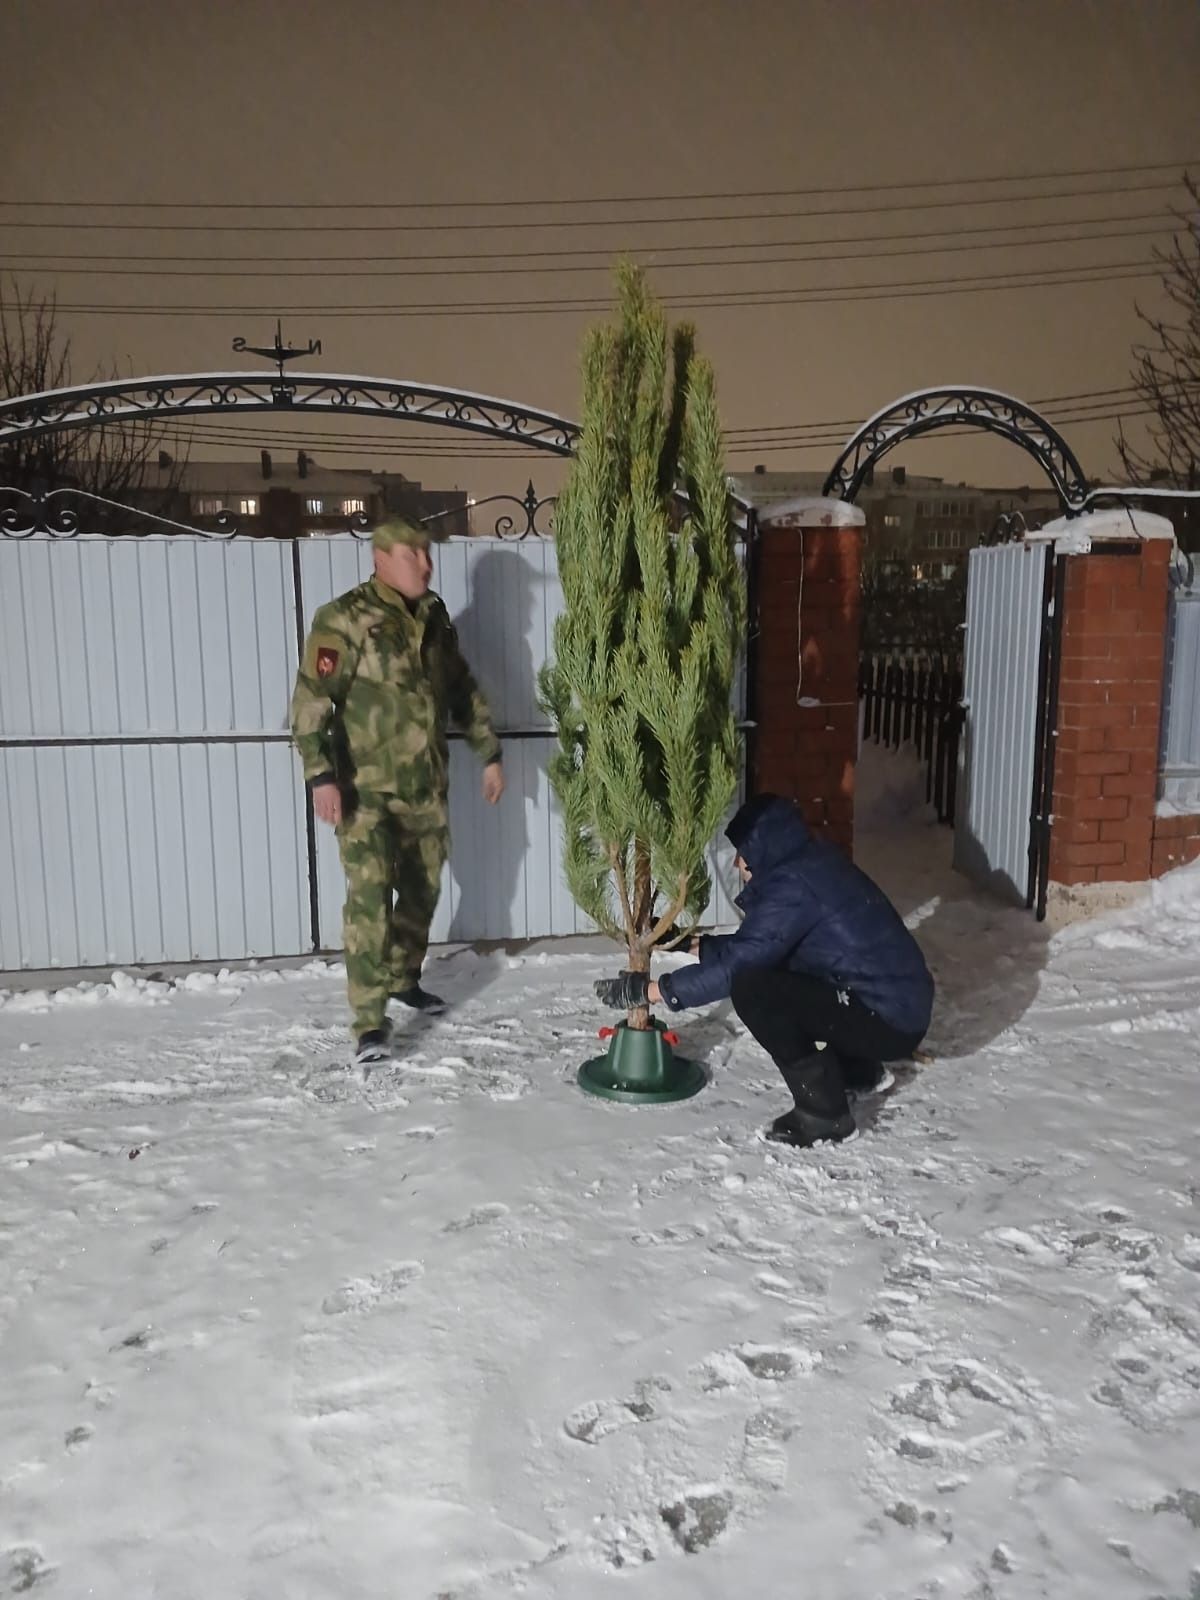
[0,162,1195,211]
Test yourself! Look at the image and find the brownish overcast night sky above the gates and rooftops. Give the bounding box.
[0,0,1200,491]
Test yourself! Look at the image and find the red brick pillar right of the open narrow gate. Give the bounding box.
[1050,538,1171,885]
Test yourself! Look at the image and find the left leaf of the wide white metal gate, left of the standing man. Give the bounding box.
[0,538,310,970]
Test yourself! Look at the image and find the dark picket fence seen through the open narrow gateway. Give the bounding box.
[858,656,963,827]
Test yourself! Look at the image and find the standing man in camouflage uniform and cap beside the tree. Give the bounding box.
[291,518,504,1061]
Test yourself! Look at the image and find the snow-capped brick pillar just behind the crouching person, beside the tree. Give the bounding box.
[750,499,864,854]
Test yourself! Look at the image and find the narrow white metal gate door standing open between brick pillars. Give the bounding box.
[954,542,1053,907]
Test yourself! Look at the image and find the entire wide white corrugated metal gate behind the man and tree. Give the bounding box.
[0,534,744,971]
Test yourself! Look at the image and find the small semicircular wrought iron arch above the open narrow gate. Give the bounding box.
[824,387,1088,515]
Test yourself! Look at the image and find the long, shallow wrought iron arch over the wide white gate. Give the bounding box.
[0,373,579,456]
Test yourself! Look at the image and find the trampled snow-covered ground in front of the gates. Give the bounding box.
[0,757,1200,1600]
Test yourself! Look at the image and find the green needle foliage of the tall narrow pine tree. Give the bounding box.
[539,262,746,1027]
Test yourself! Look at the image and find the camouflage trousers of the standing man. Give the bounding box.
[338,795,450,1034]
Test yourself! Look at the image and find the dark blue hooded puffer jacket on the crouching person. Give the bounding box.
[659,795,933,1034]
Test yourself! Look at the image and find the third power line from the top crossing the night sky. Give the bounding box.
[0,211,1178,266]
